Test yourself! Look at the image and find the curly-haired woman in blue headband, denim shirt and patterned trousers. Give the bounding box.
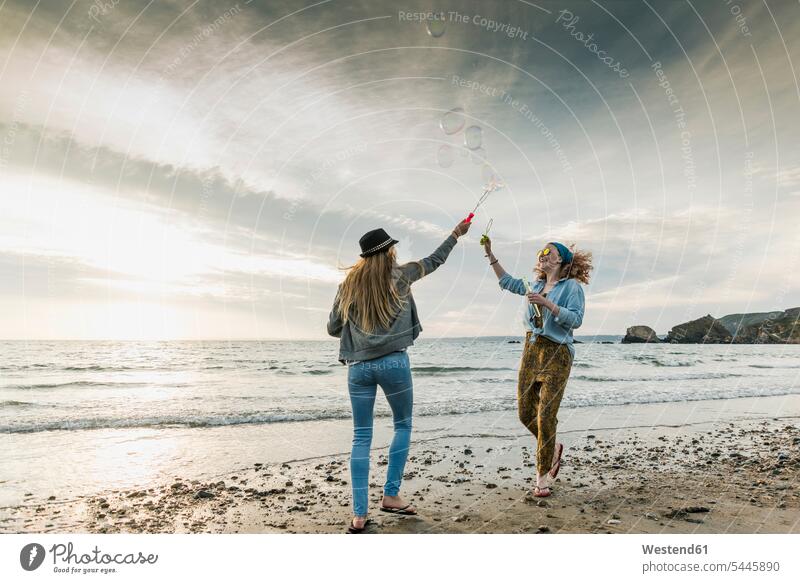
[484,237,592,497]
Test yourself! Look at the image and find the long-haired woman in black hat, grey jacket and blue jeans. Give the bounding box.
[328,221,470,533]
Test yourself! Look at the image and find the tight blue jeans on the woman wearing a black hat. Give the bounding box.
[347,352,414,516]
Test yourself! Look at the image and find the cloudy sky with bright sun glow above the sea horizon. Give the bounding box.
[0,0,800,339]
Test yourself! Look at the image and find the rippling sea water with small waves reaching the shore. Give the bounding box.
[0,337,800,505]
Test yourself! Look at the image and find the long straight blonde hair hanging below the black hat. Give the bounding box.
[339,247,407,334]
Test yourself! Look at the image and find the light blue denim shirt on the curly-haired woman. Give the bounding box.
[498,273,586,359]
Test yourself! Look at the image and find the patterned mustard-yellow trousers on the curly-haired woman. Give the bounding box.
[517,332,572,476]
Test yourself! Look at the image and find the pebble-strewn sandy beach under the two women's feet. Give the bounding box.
[0,395,800,533]
